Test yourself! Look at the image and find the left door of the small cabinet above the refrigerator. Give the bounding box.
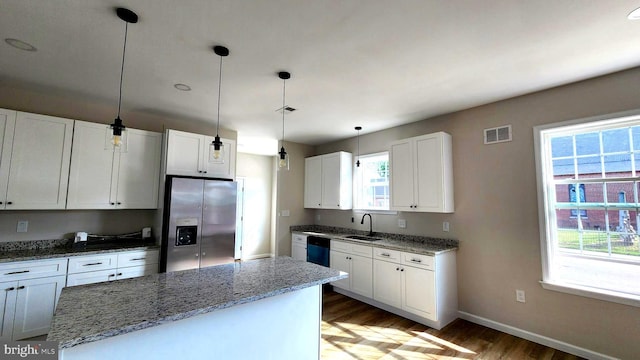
[166,130,205,176]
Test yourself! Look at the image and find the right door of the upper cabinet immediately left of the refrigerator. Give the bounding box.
[116,129,162,209]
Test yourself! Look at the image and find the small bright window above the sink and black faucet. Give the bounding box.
[353,152,389,210]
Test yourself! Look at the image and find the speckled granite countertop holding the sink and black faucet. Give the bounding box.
[290,225,458,255]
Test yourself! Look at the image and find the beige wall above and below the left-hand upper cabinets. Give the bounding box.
[0,81,237,242]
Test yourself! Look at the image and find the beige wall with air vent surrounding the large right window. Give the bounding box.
[316,68,640,359]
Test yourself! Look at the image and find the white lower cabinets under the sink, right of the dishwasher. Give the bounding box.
[330,240,458,329]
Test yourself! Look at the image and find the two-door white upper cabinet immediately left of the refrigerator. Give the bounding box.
[67,121,162,209]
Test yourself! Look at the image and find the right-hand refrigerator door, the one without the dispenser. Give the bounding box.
[200,180,237,267]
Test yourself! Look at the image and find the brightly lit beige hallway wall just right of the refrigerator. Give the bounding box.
[236,153,275,259]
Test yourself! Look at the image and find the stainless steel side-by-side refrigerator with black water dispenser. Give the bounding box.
[160,176,237,272]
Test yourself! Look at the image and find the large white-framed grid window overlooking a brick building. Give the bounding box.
[534,110,640,306]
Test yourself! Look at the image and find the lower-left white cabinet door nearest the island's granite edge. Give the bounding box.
[13,276,65,340]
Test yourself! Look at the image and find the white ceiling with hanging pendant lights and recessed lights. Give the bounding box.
[0,0,640,152]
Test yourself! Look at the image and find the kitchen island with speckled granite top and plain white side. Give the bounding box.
[47,257,347,359]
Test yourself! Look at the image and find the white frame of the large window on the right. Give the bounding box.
[533,110,640,307]
